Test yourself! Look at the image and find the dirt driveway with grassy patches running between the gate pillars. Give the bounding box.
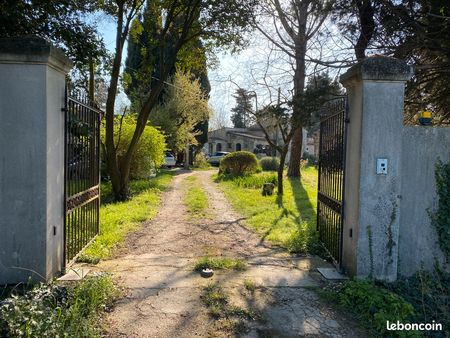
[99,171,361,338]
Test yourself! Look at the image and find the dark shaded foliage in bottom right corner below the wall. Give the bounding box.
[385,267,450,337]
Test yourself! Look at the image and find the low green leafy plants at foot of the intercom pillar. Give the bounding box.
[324,280,414,337]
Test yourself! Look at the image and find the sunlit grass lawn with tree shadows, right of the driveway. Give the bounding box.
[216,166,322,253]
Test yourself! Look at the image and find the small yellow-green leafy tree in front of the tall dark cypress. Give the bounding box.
[151,71,211,165]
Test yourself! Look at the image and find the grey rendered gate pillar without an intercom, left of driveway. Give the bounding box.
[0,37,71,284]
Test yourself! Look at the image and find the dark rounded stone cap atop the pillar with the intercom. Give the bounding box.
[340,55,414,86]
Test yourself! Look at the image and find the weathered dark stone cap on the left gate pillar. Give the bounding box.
[0,36,73,74]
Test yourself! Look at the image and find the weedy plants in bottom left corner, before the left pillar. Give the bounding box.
[0,275,118,338]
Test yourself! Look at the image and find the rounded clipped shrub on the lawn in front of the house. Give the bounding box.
[219,151,259,176]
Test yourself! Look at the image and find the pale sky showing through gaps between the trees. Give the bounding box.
[92,9,354,126]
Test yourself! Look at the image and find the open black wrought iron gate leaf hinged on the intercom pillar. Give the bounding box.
[317,98,347,268]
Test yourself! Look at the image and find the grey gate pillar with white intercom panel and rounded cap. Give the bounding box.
[340,56,412,281]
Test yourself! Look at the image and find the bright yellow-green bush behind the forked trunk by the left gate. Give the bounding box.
[102,115,166,179]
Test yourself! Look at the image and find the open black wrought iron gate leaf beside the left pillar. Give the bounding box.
[63,89,102,264]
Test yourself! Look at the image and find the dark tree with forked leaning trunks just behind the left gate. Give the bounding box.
[105,0,254,200]
